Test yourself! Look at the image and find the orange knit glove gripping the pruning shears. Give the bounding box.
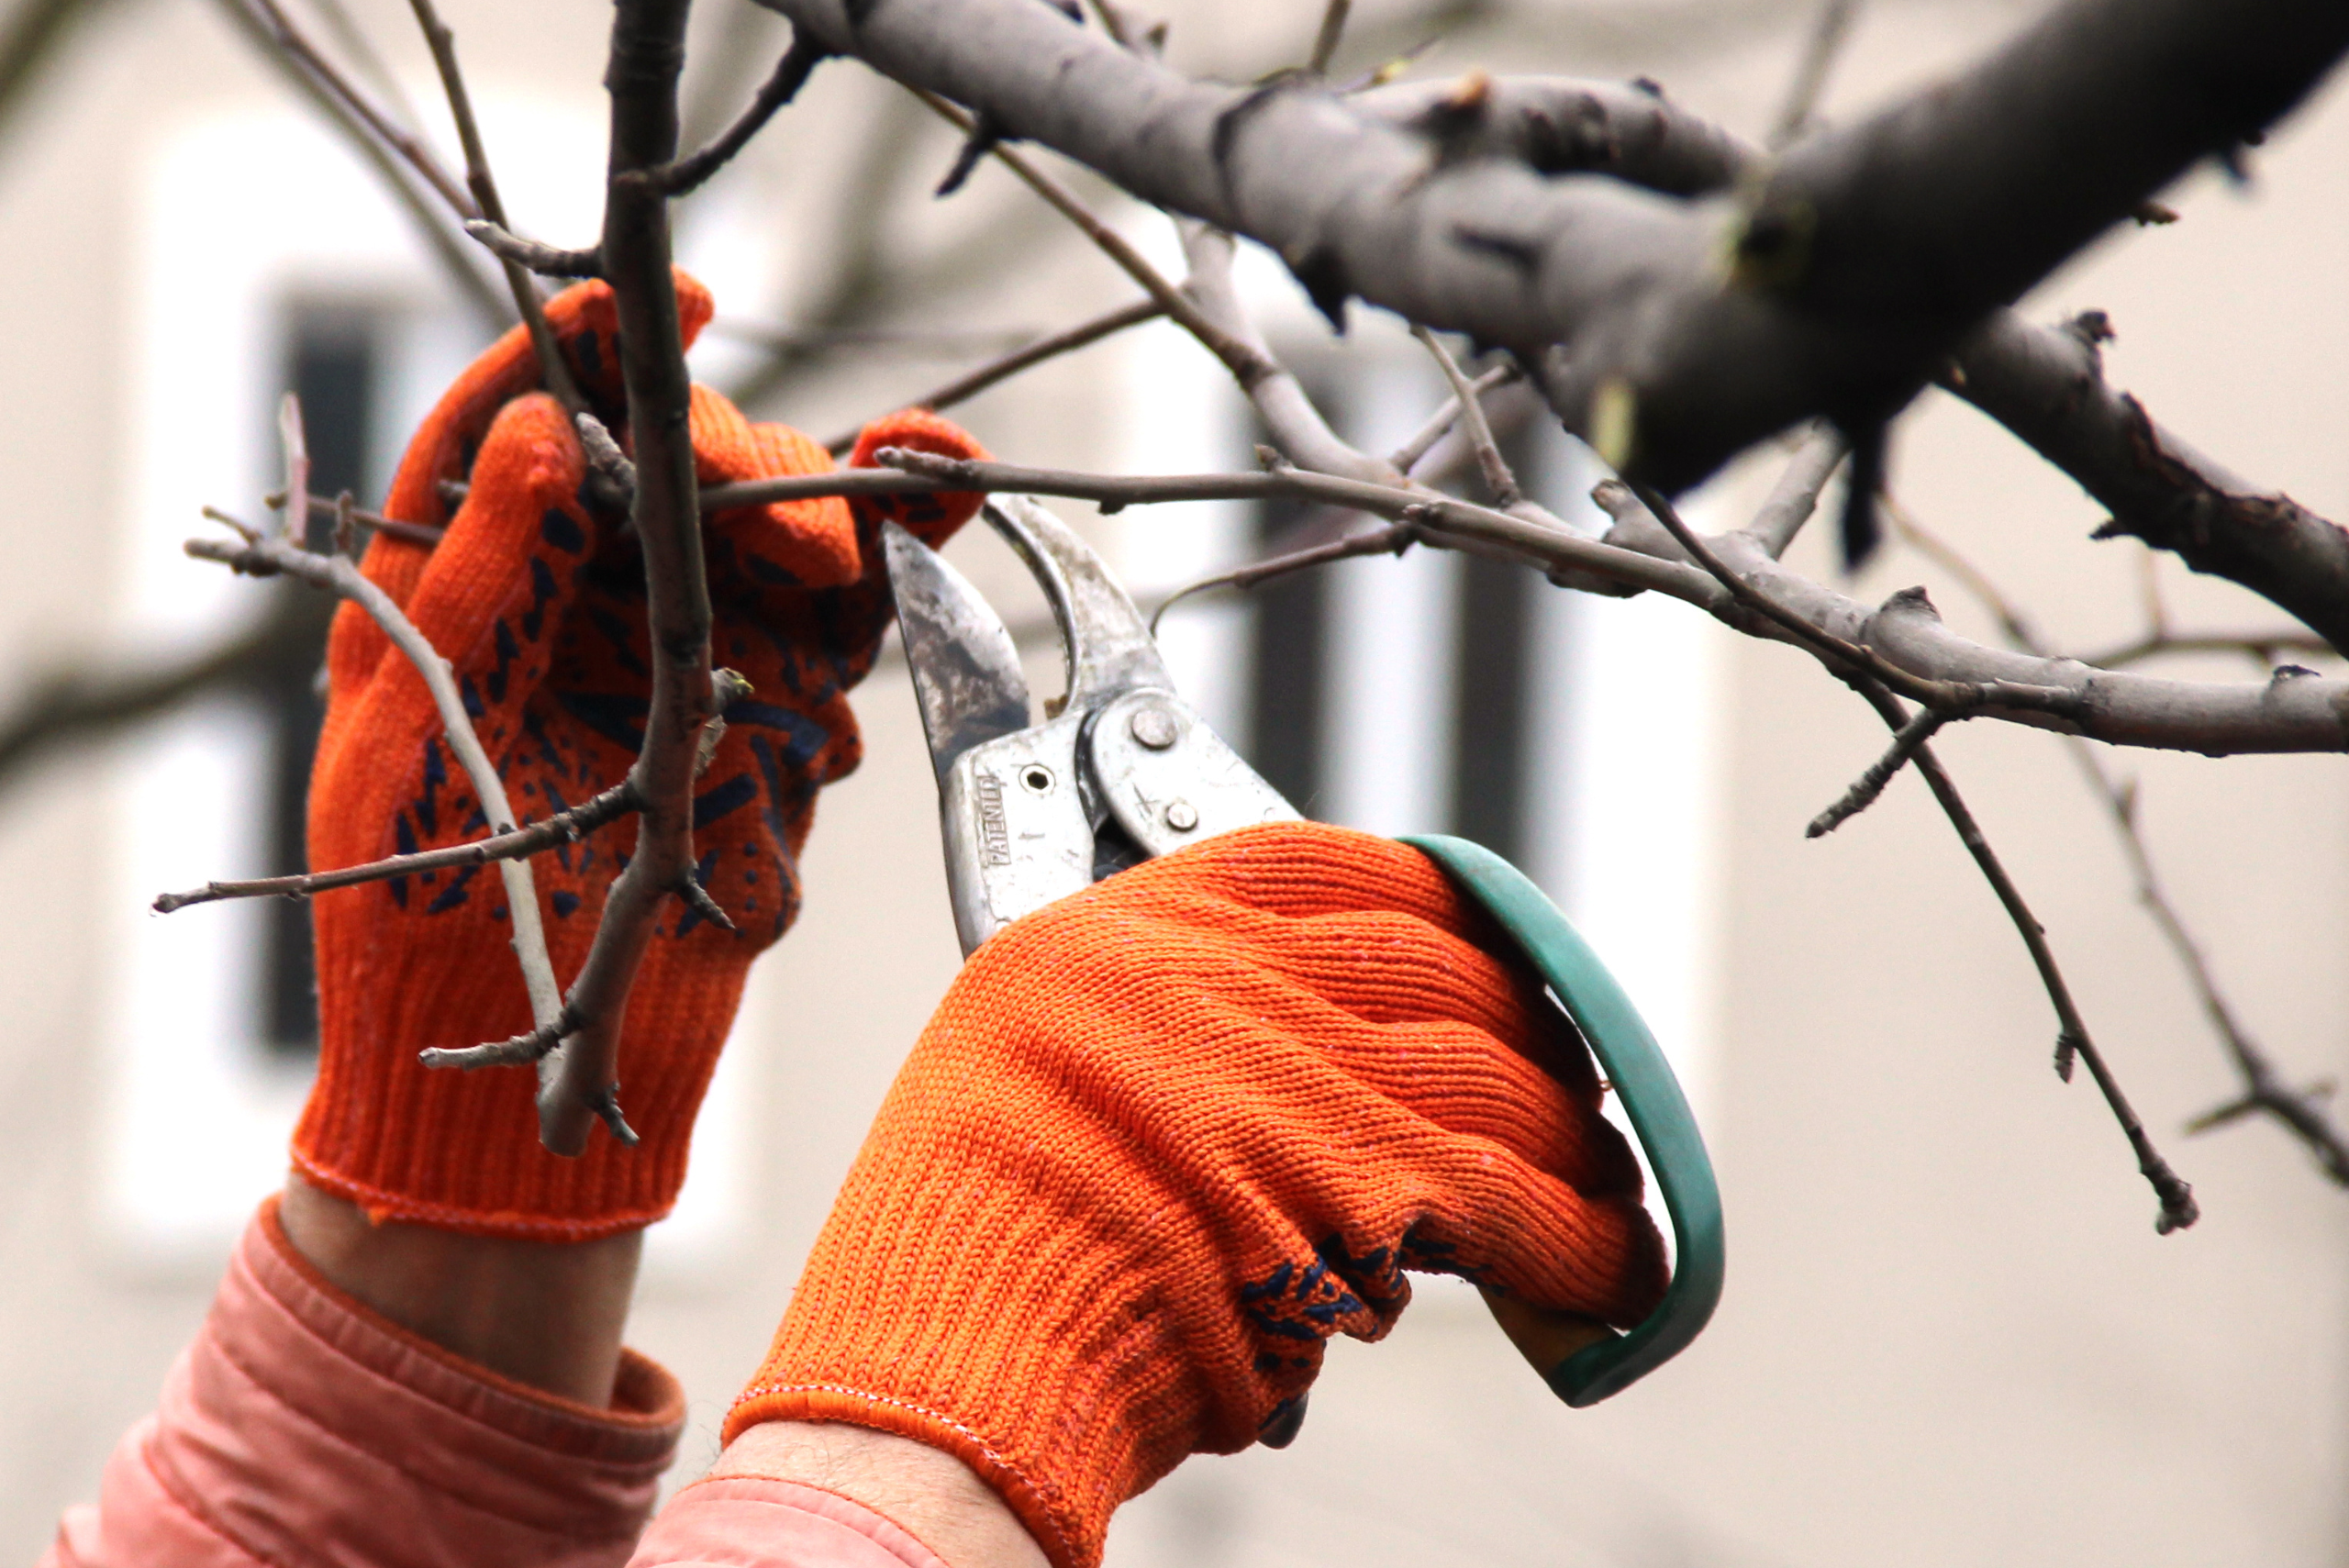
[726,824,1665,1568]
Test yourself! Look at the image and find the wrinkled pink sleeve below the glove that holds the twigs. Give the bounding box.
[42,1199,685,1568]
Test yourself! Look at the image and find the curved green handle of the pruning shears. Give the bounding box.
[1402,833,1721,1406]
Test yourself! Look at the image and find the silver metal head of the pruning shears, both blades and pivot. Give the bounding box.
[885,495,1297,953]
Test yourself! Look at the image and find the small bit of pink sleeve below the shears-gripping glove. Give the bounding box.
[628,1476,947,1568]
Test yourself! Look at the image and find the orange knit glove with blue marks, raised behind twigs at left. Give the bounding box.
[294,274,982,1240]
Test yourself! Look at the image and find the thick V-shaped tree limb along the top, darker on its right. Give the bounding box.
[771,0,2349,491]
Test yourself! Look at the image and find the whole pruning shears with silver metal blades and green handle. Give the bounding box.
[884,495,1721,1406]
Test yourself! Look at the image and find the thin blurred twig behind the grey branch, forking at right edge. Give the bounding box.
[1887,497,2349,1185]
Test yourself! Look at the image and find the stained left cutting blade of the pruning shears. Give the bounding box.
[881,524,1029,784]
